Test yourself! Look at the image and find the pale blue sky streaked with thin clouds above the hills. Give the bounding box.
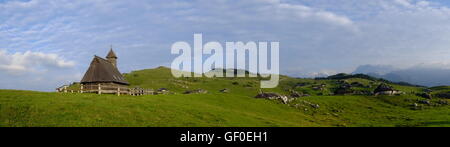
[0,0,450,91]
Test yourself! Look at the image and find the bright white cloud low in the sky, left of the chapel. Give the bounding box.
[0,50,75,75]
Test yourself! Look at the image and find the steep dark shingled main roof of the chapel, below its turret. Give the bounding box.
[81,56,129,85]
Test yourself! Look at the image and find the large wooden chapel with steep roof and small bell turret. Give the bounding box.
[81,48,129,95]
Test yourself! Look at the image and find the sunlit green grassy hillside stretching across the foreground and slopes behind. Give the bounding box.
[0,67,450,127]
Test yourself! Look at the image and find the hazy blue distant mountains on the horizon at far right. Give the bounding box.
[353,65,450,87]
